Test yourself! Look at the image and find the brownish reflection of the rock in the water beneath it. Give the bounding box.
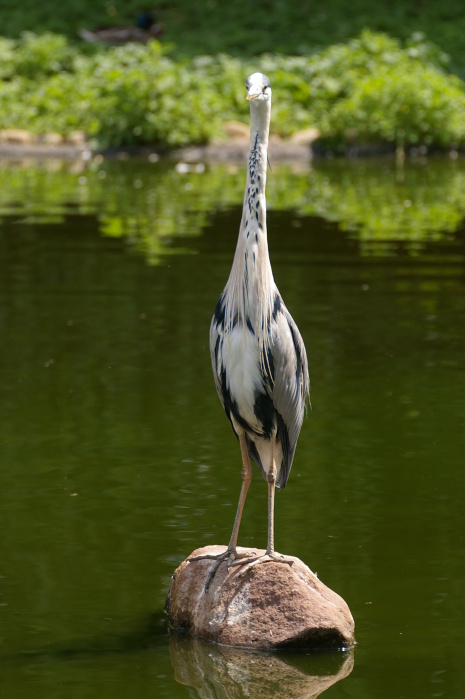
[170,635,354,699]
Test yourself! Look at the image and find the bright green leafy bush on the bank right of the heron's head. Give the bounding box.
[304,32,465,146]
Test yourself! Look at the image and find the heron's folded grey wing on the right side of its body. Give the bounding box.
[270,301,310,488]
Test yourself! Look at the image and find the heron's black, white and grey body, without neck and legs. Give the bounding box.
[210,233,308,488]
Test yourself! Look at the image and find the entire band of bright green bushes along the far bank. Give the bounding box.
[0,31,465,148]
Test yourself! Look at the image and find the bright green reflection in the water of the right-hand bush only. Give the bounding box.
[302,160,465,255]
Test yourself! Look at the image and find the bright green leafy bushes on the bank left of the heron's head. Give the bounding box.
[0,37,224,147]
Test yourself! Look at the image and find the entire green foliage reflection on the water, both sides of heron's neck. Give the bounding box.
[0,159,465,264]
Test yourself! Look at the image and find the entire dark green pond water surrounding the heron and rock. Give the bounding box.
[0,156,465,699]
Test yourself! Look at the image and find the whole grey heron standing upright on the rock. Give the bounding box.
[198,73,310,589]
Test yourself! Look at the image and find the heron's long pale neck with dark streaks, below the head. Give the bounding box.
[227,102,274,336]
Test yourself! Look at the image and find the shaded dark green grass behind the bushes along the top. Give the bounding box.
[1,0,465,71]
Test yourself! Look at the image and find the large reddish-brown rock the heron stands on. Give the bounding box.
[167,546,355,648]
